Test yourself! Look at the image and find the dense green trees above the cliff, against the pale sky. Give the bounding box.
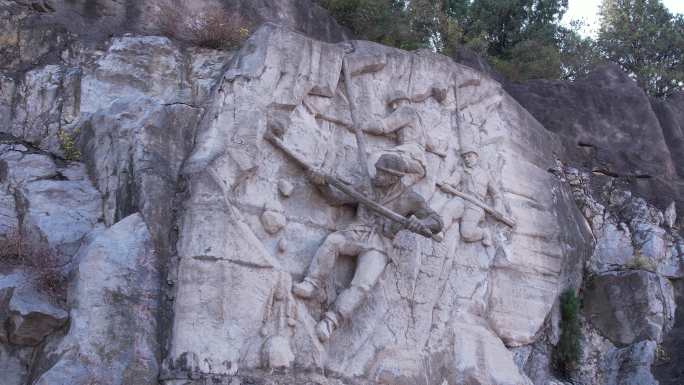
[319,0,684,96]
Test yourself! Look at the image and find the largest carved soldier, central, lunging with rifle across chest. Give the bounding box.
[293,154,442,341]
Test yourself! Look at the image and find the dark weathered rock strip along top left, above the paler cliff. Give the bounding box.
[0,0,349,58]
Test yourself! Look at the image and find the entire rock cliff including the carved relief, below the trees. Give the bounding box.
[0,0,684,385]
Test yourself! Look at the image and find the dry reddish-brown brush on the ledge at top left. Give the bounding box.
[159,2,249,49]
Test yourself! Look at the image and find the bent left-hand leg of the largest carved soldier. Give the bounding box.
[292,232,361,299]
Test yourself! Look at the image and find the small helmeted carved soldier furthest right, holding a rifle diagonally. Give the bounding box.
[439,147,503,246]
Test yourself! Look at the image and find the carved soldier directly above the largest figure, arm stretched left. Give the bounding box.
[361,91,427,178]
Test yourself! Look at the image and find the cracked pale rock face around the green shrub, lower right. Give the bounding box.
[561,168,684,384]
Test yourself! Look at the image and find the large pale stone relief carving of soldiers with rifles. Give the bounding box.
[167,27,560,385]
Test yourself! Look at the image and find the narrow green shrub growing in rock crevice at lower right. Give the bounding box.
[552,289,582,379]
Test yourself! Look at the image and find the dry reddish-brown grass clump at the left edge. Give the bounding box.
[0,231,67,303]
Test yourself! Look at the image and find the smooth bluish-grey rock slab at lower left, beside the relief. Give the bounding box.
[34,214,160,385]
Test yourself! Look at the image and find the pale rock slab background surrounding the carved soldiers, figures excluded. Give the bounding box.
[163,26,590,384]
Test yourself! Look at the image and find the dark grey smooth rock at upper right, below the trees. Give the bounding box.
[506,65,684,220]
